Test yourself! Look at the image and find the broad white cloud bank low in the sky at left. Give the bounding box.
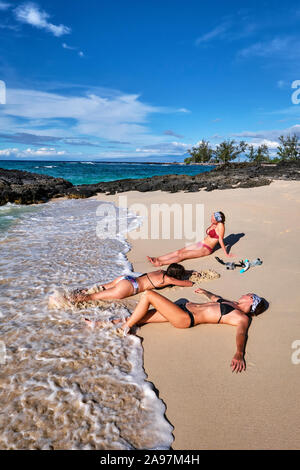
[0,84,171,145]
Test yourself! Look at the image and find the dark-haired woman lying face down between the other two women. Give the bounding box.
[71,263,193,302]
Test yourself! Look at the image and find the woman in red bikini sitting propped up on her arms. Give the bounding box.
[147,211,234,266]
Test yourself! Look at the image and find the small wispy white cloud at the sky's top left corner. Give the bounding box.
[14,2,71,37]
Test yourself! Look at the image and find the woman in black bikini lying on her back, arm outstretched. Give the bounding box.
[86,288,267,372]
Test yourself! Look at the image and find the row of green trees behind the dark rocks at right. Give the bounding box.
[184,134,300,164]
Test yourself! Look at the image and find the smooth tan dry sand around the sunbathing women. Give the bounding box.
[98,181,300,450]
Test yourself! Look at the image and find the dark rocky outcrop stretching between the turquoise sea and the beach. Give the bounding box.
[0,162,300,205]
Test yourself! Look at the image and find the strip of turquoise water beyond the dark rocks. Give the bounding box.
[0,160,214,185]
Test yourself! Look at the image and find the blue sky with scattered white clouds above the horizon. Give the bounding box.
[0,0,300,161]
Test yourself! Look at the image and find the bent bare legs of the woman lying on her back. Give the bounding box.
[122,291,190,332]
